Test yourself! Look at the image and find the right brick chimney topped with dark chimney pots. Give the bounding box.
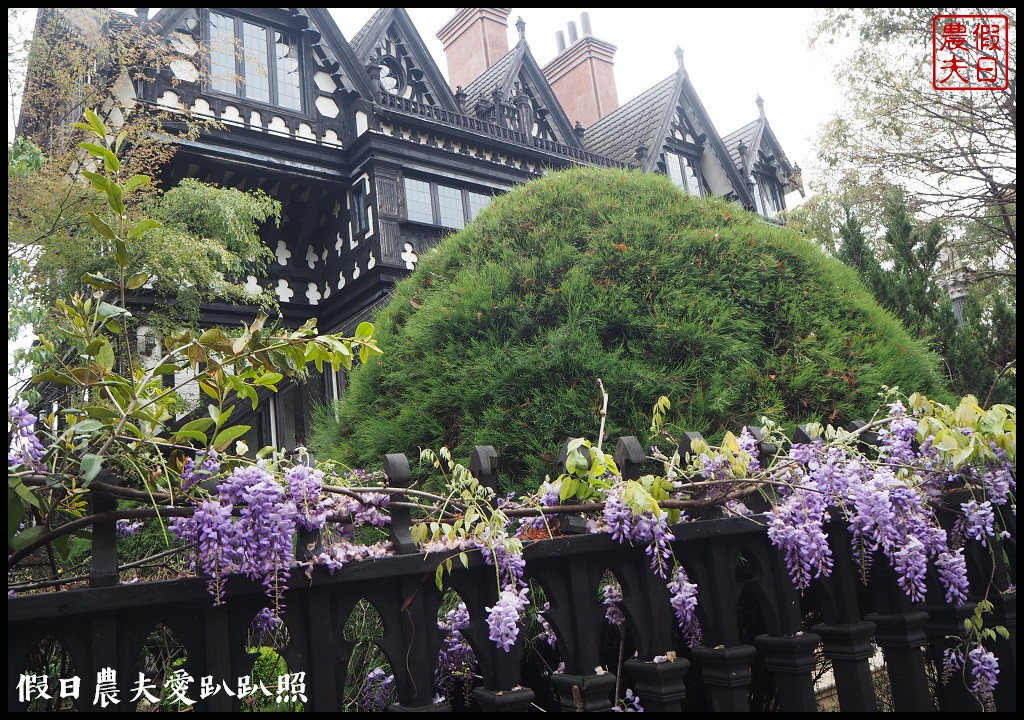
[544,12,618,127]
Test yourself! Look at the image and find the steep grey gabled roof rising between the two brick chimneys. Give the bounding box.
[463,20,584,150]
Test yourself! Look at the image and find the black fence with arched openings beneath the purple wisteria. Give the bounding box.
[7,434,1016,712]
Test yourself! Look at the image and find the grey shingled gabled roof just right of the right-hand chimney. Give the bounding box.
[585,57,754,207]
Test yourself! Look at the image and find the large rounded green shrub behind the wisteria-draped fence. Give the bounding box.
[316,169,943,491]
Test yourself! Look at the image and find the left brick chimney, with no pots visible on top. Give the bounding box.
[437,7,512,91]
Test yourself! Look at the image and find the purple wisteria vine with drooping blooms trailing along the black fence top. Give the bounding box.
[8,395,1017,710]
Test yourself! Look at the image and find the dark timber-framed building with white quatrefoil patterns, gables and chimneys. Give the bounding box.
[14,8,802,449]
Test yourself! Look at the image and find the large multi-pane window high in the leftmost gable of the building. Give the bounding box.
[209,12,302,112]
